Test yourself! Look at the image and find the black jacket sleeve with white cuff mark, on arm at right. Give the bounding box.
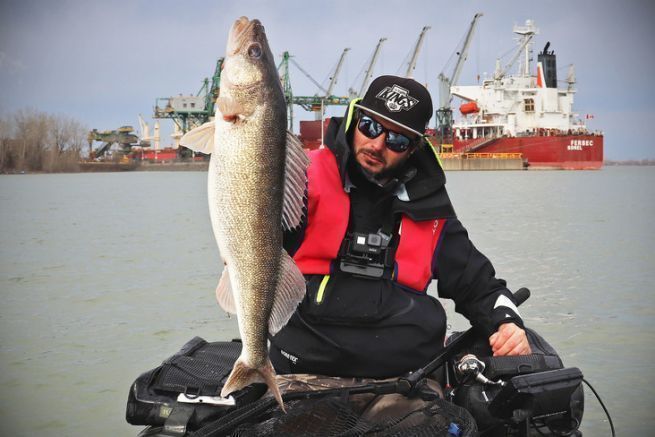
[432,219,523,336]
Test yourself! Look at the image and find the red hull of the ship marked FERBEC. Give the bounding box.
[453,135,603,170]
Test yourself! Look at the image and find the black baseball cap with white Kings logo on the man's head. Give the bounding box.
[355,76,432,135]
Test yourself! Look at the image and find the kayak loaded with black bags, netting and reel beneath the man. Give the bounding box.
[126,329,584,437]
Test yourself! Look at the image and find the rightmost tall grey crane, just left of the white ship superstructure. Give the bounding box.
[436,12,483,141]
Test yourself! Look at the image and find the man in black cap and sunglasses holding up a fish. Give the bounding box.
[271,76,530,378]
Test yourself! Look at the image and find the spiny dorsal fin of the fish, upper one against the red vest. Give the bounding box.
[282,131,309,230]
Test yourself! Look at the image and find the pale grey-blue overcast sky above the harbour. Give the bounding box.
[0,0,655,160]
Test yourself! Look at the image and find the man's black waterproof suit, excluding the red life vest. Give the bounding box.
[271,110,523,378]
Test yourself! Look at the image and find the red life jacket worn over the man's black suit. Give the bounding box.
[293,148,446,291]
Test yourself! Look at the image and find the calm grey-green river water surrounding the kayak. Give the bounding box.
[0,167,655,436]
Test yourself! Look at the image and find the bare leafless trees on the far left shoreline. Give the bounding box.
[0,109,89,173]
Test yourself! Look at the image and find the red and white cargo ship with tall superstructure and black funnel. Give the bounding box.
[452,20,603,170]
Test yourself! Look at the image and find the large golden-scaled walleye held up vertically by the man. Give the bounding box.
[181,17,309,409]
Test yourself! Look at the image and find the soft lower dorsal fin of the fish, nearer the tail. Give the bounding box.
[268,249,307,335]
